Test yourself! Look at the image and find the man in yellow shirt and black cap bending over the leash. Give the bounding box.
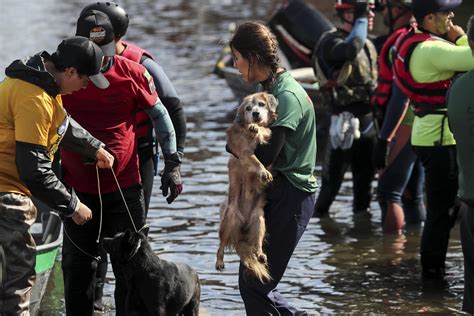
[0,36,114,315]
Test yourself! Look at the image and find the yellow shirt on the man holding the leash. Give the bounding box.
[0,77,69,195]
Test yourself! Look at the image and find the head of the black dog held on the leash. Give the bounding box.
[102,229,147,262]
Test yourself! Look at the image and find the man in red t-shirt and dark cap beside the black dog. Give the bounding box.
[61,10,181,316]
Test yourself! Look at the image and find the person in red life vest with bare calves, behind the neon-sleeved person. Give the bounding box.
[372,0,426,234]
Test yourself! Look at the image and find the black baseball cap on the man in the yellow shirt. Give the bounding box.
[51,36,109,89]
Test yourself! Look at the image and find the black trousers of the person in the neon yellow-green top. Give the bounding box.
[413,145,458,270]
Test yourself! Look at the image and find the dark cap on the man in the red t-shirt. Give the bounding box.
[76,10,116,57]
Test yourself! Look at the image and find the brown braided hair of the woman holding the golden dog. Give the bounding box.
[229,21,280,82]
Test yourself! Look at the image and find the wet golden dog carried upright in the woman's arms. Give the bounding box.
[216,92,278,282]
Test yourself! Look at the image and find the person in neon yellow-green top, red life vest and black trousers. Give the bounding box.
[393,0,474,278]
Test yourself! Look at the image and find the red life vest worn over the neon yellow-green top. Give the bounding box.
[393,29,451,116]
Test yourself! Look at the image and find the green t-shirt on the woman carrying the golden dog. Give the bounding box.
[270,71,317,192]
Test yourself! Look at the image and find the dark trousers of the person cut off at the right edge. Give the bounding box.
[461,202,474,314]
